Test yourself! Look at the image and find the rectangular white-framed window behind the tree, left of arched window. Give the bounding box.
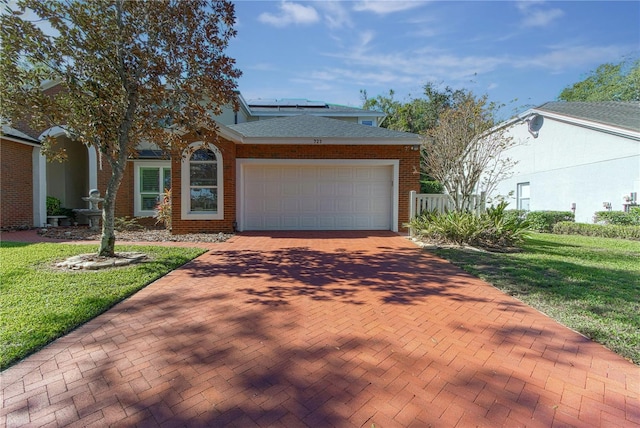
[134,161,171,217]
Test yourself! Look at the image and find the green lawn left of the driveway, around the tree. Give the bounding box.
[0,242,205,370]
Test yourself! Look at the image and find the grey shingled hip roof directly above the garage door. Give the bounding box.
[221,115,420,144]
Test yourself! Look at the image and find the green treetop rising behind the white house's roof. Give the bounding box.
[558,59,640,101]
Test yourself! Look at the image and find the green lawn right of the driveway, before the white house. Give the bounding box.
[434,234,640,364]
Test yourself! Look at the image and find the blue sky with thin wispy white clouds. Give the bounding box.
[227,0,640,114]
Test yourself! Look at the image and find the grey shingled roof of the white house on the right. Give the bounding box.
[534,101,640,132]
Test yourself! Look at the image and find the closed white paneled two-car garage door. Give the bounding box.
[243,165,393,230]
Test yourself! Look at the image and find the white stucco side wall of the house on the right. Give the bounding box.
[496,117,640,223]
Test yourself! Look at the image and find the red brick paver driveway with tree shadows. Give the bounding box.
[0,232,640,428]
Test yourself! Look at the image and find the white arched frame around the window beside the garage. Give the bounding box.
[180,141,224,220]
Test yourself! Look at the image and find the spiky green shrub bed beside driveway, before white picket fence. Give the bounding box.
[409,202,529,248]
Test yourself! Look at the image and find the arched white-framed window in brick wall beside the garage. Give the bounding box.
[181,142,224,220]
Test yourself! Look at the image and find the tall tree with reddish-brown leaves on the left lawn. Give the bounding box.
[0,0,241,256]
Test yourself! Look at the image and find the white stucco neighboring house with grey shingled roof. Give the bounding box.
[496,102,640,223]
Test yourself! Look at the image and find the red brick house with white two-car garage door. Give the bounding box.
[2,88,420,234]
